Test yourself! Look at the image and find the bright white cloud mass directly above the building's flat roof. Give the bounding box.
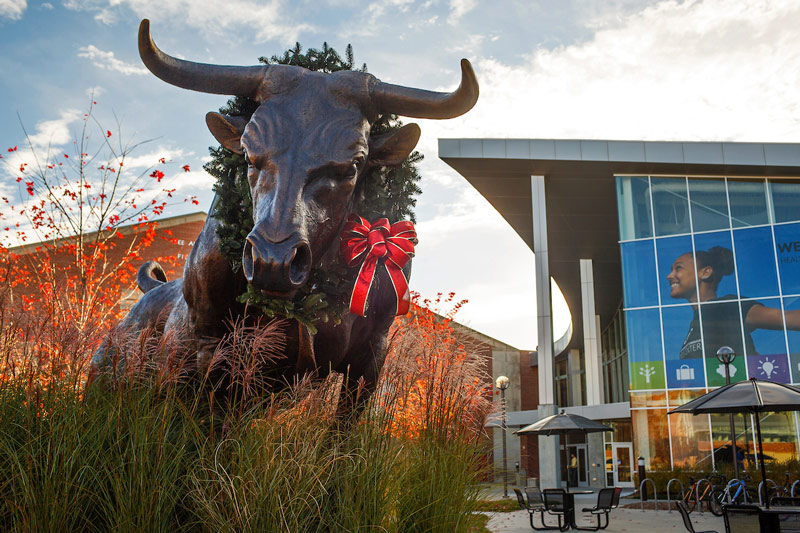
[426,0,800,141]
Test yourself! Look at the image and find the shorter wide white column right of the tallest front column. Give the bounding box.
[581,259,603,405]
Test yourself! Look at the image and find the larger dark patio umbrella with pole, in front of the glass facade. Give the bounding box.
[669,378,800,508]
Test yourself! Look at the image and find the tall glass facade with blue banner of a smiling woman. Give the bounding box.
[620,176,800,468]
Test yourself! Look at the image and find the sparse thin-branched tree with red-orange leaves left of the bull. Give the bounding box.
[0,100,190,380]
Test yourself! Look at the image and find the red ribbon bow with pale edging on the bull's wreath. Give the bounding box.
[340,214,417,316]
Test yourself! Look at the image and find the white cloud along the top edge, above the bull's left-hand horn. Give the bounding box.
[64,0,312,44]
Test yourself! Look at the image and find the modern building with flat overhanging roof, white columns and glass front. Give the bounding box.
[439,139,800,486]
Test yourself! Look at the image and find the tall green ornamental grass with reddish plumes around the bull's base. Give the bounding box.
[0,298,491,533]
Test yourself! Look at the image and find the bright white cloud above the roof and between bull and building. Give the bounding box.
[404,0,800,349]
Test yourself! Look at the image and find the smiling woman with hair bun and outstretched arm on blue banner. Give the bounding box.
[667,246,800,359]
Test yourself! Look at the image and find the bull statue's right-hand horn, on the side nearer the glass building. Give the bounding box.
[372,59,478,118]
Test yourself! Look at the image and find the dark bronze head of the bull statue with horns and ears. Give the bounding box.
[139,20,478,297]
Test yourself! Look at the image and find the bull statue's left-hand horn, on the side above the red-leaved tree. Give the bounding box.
[139,19,269,97]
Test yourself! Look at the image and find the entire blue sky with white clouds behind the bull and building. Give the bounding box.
[0,0,800,350]
